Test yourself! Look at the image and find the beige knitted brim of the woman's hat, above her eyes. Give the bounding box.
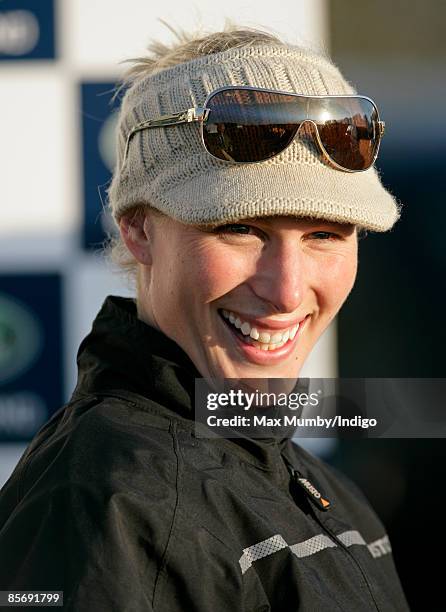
[147,163,399,232]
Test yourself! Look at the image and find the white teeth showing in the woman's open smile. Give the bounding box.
[218,309,303,351]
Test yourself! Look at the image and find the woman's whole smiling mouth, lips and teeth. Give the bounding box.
[218,309,311,365]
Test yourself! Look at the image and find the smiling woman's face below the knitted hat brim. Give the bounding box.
[134,217,357,378]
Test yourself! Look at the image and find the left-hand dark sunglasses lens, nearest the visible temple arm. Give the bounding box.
[203,89,307,162]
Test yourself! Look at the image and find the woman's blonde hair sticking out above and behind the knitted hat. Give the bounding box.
[103,21,287,288]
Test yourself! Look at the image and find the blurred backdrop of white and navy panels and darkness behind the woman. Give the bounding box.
[0,0,446,610]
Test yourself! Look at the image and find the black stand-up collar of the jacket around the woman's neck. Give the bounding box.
[73,295,289,470]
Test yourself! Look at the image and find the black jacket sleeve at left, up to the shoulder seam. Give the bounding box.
[0,397,181,610]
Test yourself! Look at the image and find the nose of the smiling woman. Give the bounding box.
[250,237,307,314]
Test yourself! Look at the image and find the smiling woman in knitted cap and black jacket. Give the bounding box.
[0,29,408,612]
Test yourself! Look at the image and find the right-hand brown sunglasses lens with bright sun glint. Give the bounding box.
[308,97,379,170]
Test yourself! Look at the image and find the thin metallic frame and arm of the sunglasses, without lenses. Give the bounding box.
[121,85,386,173]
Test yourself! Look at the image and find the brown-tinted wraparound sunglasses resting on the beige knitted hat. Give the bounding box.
[122,85,385,172]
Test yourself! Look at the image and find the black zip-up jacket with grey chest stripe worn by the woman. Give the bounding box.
[0,296,408,612]
